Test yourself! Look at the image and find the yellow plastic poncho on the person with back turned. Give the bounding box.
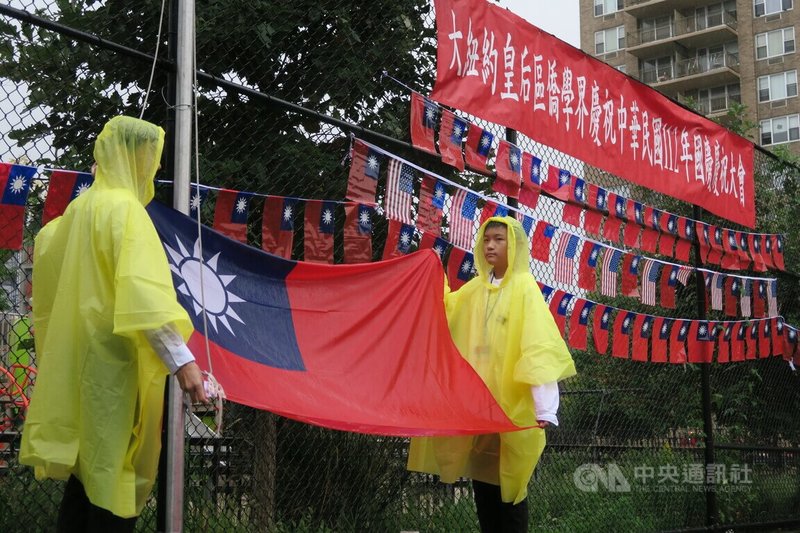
[20,117,191,518]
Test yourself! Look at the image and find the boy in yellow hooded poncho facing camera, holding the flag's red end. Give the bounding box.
[408,217,575,532]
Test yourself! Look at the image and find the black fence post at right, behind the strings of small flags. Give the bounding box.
[693,205,719,531]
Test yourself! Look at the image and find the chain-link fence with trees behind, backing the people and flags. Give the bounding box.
[0,0,800,531]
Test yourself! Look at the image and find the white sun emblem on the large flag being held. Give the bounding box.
[164,236,245,336]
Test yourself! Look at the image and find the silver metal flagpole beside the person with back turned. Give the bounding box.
[165,0,194,532]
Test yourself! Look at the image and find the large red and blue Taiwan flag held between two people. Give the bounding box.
[148,202,519,436]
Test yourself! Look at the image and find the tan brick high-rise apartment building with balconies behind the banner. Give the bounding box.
[580,0,800,154]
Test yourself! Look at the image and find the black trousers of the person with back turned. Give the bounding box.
[56,476,137,533]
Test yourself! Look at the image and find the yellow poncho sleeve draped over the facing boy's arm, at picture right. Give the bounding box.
[514,278,576,385]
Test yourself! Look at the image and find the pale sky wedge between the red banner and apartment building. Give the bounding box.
[498,0,581,48]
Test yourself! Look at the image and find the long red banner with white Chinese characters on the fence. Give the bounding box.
[431,0,755,228]
